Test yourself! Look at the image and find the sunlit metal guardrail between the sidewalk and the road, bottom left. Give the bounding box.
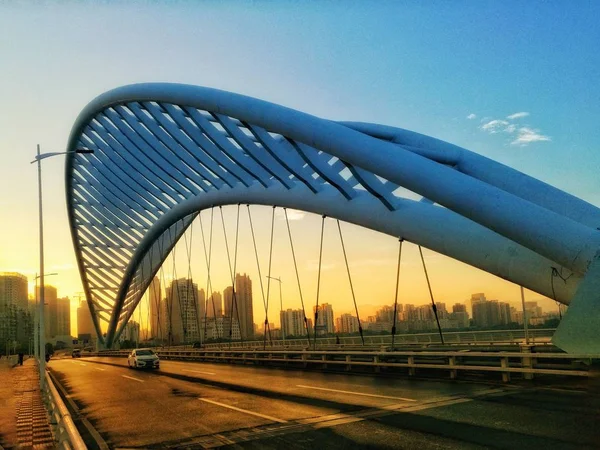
[42,372,87,450]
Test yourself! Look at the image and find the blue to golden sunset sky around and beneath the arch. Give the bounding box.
[0,0,600,333]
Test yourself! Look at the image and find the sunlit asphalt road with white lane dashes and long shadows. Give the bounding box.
[49,358,600,450]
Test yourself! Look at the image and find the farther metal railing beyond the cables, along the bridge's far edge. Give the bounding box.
[198,328,556,349]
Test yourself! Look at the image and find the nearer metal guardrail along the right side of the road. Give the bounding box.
[89,345,600,382]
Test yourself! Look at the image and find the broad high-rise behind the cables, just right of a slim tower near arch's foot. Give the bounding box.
[164,278,202,344]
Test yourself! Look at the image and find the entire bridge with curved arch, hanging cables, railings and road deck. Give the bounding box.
[9,83,600,449]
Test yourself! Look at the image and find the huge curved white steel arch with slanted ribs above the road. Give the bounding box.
[66,83,600,352]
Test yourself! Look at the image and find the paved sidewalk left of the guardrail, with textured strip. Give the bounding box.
[0,358,54,449]
